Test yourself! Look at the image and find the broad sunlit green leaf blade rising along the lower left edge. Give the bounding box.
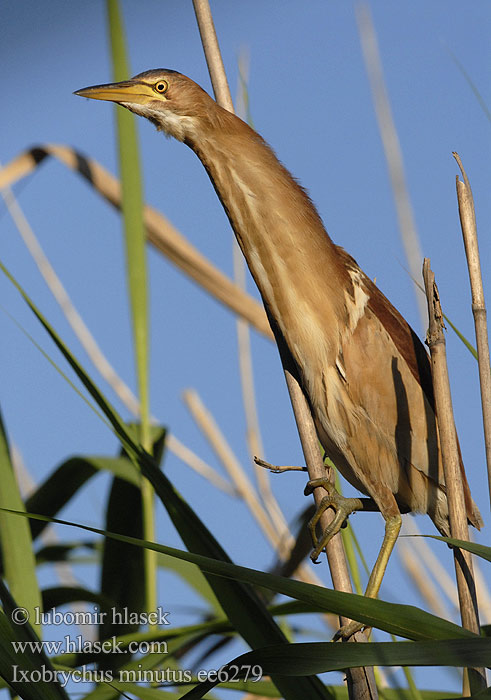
[0,413,42,636]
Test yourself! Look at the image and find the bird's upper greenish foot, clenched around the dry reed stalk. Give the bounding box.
[304,477,363,564]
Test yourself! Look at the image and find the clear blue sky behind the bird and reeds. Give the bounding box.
[0,0,491,688]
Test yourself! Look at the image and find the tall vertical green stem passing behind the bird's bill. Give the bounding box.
[107,0,157,624]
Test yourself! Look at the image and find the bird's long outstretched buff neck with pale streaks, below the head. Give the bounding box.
[184,113,346,356]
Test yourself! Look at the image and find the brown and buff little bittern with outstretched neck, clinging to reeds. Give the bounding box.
[76,70,482,633]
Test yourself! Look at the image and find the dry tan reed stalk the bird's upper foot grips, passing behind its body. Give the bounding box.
[193,0,378,700]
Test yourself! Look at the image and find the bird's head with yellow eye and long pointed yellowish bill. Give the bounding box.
[75,68,219,141]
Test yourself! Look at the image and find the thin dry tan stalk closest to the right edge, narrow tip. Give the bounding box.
[453,153,491,504]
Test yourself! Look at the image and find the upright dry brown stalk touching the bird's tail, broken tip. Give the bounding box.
[423,258,486,694]
